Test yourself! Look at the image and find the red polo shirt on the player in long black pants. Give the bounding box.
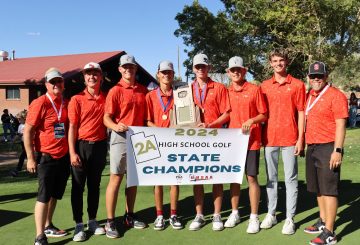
[68,88,107,141]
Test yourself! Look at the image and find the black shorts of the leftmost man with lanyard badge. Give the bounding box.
[37,153,70,203]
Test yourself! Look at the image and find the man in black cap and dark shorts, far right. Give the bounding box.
[304,62,349,245]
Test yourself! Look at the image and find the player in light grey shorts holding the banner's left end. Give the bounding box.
[104,54,147,238]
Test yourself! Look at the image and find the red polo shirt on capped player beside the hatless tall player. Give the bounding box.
[228,82,267,150]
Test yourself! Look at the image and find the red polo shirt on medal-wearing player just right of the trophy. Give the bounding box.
[192,78,231,127]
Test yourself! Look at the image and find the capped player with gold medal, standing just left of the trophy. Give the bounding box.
[146,61,183,230]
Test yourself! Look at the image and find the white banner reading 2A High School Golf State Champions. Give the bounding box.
[126,127,249,186]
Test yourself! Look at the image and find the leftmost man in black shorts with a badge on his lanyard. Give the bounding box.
[24,68,70,245]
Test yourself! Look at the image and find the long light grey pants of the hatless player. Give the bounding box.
[265,146,298,218]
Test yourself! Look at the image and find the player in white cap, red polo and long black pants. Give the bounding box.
[68,62,107,242]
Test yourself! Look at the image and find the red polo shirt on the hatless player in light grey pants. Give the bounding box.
[261,75,305,146]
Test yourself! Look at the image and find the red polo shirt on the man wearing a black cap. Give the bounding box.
[305,87,349,144]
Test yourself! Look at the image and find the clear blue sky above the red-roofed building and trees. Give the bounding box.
[0,0,223,80]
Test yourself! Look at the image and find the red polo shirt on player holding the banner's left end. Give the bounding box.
[105,79,147,126]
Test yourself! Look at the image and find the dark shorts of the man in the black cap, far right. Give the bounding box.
[306,142,340,196]
